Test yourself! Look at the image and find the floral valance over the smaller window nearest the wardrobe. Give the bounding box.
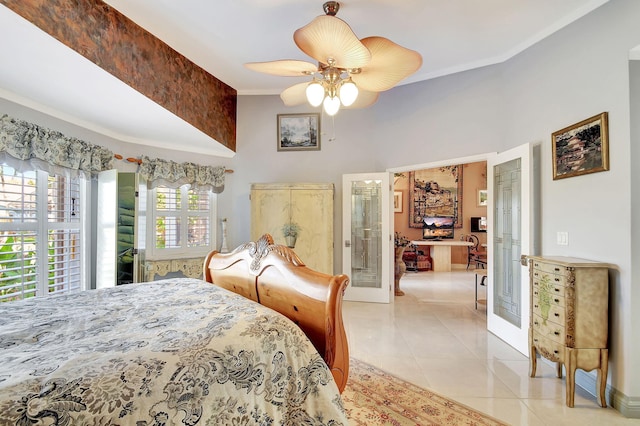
[138,156,225,194]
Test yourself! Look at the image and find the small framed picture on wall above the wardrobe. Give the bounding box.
[278,113,320,151]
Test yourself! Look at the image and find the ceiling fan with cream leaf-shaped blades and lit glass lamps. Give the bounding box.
[245,1,422,115]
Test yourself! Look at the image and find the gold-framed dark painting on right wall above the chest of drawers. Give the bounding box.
[551,112,609,180]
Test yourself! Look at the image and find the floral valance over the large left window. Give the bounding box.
[0,114,114,175]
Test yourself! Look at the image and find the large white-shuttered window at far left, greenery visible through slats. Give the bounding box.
[0,165,86,302]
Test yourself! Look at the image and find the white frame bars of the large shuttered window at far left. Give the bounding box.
[0,170,91,298]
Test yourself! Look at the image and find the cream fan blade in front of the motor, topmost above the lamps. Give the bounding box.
[293,15,371,68]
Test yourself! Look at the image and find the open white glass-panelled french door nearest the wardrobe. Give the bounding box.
[342,173,393,303]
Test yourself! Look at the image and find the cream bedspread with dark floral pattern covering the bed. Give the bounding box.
[0,278,348,426]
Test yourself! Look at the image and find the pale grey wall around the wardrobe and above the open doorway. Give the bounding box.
[228,64,502,272]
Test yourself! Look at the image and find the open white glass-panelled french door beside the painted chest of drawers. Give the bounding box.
[487,144,536,355]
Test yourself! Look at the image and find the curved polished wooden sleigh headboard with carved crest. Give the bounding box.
[203,234,349,392]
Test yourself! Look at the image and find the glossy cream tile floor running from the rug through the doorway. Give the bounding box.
[344,271,640,425]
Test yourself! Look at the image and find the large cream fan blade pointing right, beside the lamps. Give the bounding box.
[351,37,422,92]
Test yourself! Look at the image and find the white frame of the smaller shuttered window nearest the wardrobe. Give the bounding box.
[146,185,218,260]
